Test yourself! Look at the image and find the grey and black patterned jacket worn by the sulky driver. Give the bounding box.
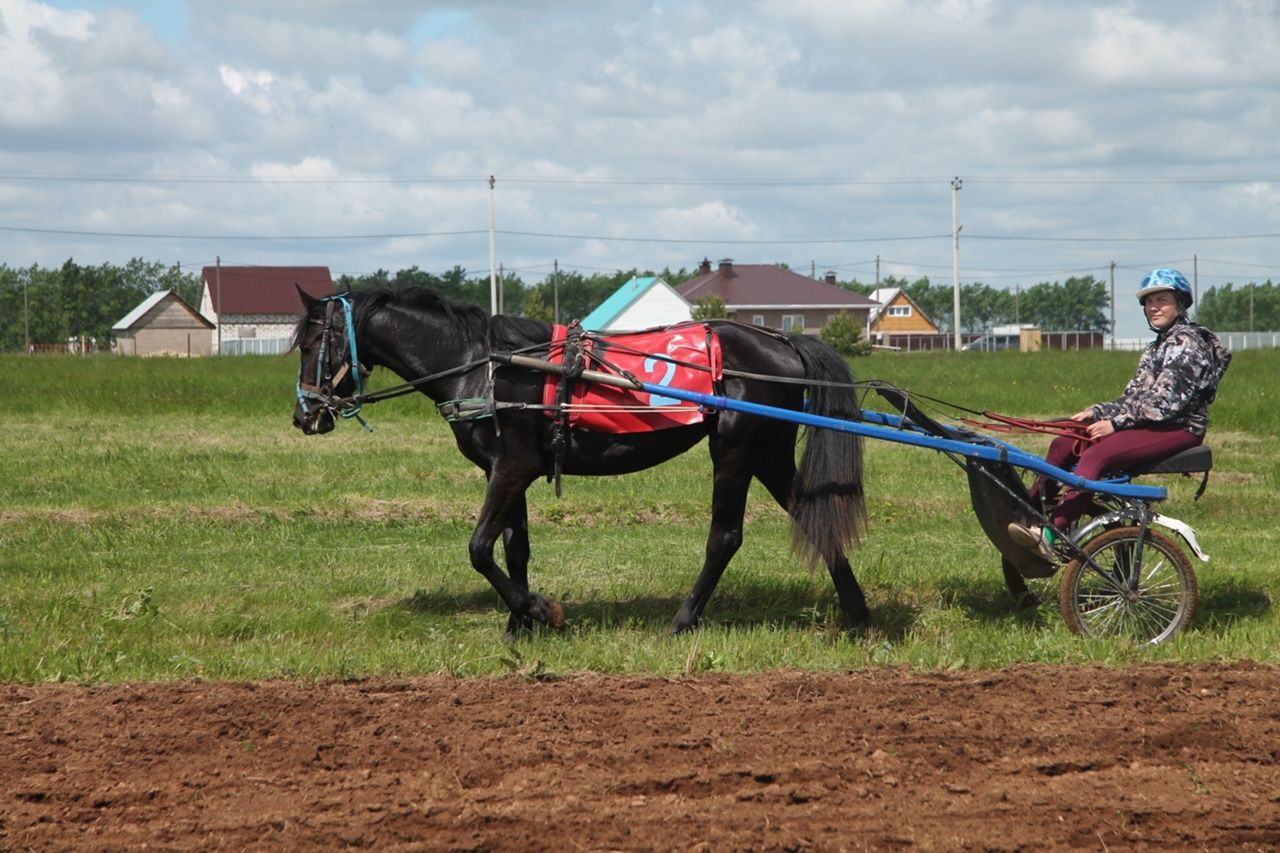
[1092,316,1231,435]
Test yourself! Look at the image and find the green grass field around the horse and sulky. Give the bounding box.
[0,351,1280,681]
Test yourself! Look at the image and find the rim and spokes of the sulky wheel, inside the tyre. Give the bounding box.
[1074,537,1188,643]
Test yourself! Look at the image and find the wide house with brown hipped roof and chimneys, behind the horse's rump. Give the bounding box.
[676,259,876,334]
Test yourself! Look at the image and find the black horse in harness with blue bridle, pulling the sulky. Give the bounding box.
[293,288,869,634]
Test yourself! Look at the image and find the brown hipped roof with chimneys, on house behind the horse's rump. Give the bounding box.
[676,260,876,309]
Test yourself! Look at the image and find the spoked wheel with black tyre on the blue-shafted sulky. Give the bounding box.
[1057,526,1196,643]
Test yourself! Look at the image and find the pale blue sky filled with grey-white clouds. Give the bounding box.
[0,0,1280,338]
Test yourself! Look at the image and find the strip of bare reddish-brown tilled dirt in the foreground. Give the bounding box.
[0,665,1280,850]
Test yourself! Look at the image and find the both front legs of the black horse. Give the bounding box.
[467,474,564,628]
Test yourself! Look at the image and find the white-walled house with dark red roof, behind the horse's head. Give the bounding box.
[200,265,333,355]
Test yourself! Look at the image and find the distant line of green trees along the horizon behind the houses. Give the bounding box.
[0,257,1280,352]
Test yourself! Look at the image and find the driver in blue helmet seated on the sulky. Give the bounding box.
[1009,269,1231,562]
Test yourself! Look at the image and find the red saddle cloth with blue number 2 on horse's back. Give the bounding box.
[543,323,723,434]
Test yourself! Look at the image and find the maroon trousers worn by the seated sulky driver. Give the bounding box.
[1032,427,1204,530]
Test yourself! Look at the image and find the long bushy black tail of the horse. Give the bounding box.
[790,334,867,565]
